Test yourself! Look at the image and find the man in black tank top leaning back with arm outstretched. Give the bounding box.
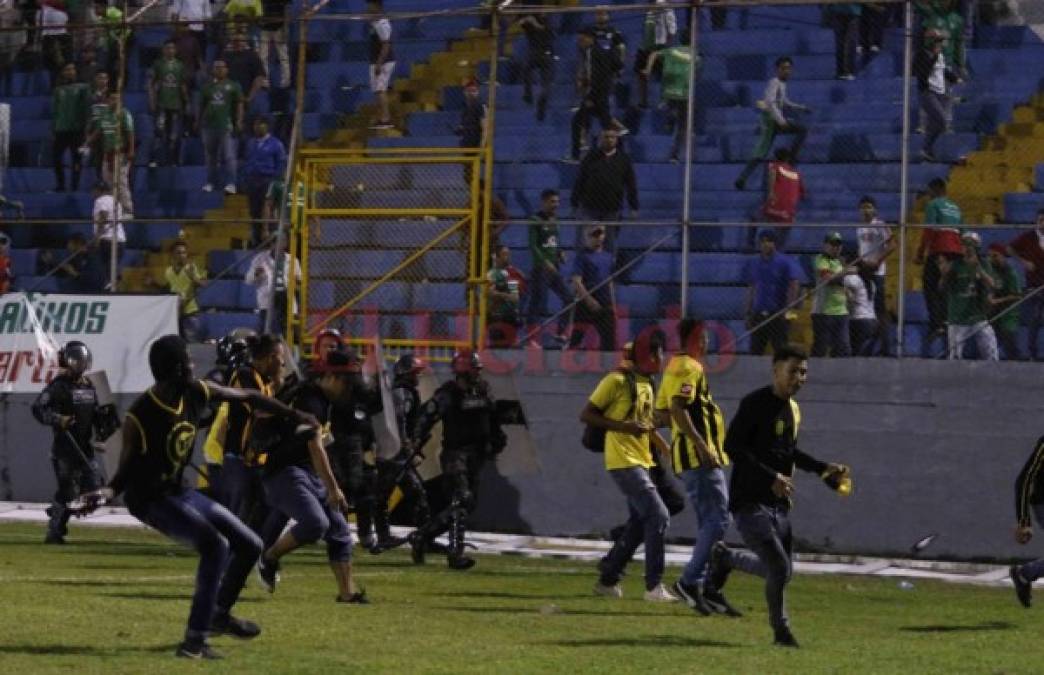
[87,335,317,658]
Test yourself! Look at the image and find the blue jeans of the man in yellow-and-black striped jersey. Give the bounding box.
[679,467,729,585]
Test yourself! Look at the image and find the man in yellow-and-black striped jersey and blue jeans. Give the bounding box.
[656,318,731,617]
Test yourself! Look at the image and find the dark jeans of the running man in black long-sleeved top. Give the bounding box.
[729,505,793,630]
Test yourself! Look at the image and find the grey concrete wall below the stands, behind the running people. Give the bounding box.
[0,344,1044,558]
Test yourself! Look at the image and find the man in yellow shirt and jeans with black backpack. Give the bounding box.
[580,342,678,602]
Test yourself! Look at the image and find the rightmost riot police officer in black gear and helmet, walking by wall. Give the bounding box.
[409,348,507,570]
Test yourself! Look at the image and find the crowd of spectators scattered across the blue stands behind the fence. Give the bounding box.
[0,0,1044,359]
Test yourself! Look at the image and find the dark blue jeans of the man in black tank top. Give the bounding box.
[126,489,261,635]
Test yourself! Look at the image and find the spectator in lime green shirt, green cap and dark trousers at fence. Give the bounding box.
[812,232,855,357]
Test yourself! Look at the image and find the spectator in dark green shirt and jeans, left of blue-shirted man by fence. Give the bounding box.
[526,190,573,347]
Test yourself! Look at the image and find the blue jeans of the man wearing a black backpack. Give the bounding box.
[600,466,670,589]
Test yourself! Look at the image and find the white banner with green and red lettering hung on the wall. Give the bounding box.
[0,293,177,393]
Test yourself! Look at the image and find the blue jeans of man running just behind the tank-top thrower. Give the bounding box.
[264,466,352,562]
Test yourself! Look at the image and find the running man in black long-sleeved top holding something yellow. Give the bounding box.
[704,346,848,647]
